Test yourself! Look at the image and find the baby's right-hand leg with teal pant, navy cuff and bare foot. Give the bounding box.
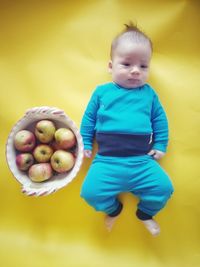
[132,159,173,235]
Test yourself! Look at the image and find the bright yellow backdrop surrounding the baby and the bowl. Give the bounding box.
[0,0,200,267]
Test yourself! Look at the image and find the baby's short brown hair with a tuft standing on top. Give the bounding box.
[110,22,153,58]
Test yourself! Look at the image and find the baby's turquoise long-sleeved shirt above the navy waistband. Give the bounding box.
[81,82,168,152]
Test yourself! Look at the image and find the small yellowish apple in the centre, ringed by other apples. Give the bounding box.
[33,144,53,163]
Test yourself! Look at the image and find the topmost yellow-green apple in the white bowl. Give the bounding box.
[35,120,56,144]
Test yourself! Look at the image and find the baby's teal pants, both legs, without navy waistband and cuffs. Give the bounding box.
[81,154,173,216]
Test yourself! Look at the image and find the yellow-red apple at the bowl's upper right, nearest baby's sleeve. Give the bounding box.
[55,128,76,149]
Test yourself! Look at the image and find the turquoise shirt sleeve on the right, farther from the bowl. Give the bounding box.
[151,94,169,152]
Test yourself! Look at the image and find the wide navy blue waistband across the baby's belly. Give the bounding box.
[96,132,152,157]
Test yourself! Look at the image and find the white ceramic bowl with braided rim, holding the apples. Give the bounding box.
[6,106,83,196]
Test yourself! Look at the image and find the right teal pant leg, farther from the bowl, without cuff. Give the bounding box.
[131,156,174,216]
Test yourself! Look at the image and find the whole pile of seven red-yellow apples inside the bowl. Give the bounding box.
[14,119,77,182]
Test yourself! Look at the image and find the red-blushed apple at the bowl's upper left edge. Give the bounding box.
[14,130,36,152]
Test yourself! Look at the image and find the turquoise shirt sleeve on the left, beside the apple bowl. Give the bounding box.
[80,89,99,150]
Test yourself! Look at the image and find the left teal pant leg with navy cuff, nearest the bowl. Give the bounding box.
[81,156,126,216]
